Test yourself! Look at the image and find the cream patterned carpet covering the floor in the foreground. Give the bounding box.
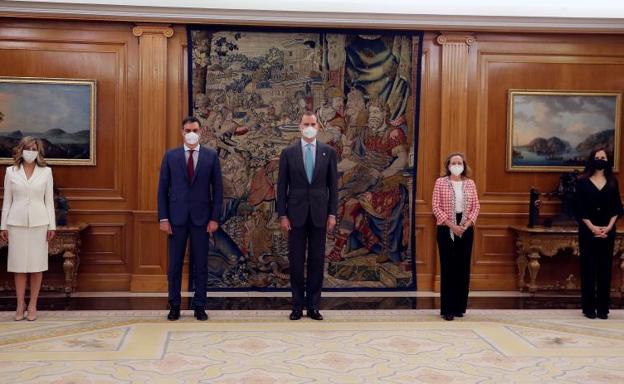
[0,310,624,384]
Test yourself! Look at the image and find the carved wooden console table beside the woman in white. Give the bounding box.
[0,223,89,297]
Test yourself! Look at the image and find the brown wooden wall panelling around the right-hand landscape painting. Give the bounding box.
[469,34,624,289]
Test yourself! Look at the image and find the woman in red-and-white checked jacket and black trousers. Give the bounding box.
[432,153,480,320]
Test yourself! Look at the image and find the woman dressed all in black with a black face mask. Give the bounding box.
[576,148,622,319]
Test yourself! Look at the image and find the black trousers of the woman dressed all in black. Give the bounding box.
[579,227,615,315]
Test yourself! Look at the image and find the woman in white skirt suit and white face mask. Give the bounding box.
[0,136,56,321]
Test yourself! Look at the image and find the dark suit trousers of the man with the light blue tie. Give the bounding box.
[288,208,327,310]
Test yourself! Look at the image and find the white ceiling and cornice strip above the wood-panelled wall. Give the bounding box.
[0,0,624,32]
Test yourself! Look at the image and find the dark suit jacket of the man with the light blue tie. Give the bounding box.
[277,139,338,227]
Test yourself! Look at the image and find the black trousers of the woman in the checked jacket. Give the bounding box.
[437,214,474,316]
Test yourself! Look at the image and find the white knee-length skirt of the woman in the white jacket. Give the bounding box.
[7,225,48,273]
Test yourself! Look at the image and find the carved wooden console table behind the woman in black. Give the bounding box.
[509,226,624,293]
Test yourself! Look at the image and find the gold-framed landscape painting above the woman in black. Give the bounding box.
[507,90,622,172]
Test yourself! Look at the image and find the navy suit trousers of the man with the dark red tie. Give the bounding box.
[167,222,209,309]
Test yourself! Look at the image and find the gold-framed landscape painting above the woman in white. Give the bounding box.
[0,77,96,165]
